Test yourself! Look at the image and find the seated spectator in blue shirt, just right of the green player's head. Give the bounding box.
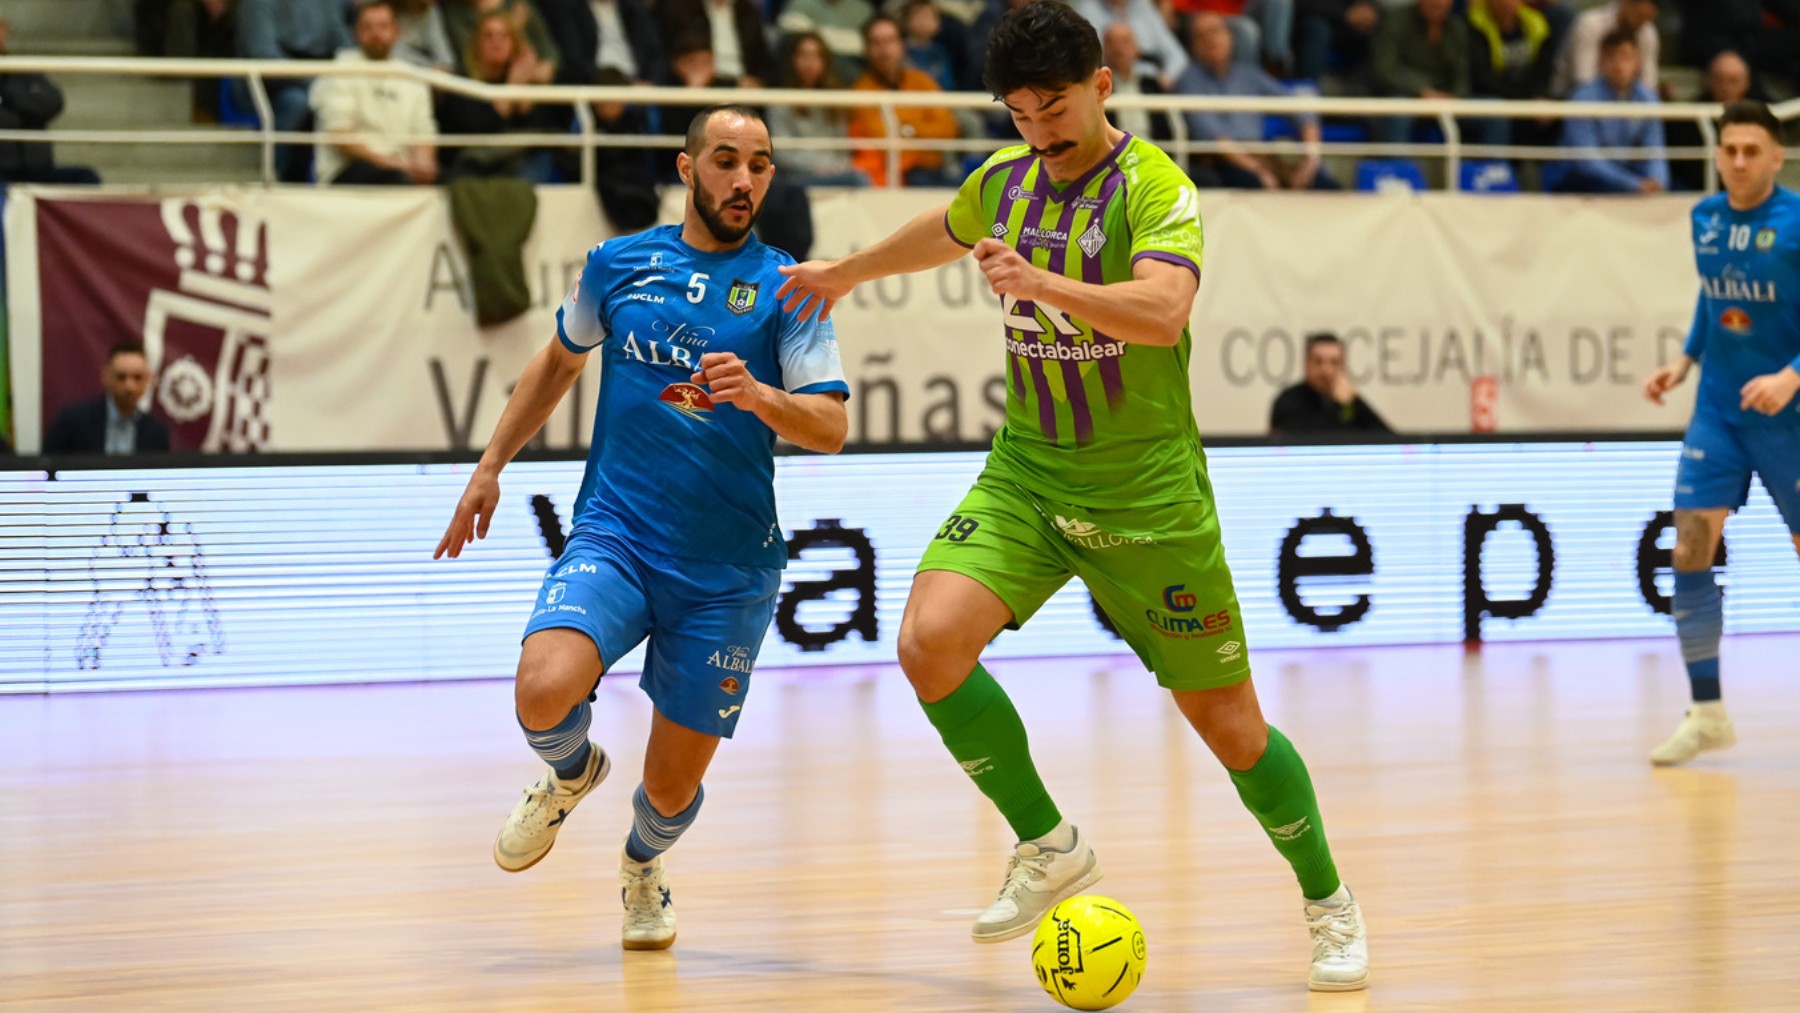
[1175,14,1341,191]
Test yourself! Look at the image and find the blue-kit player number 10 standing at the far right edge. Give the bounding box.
[1643,101,1800,765]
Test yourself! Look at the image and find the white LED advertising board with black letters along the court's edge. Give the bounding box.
[0,443,1800,693]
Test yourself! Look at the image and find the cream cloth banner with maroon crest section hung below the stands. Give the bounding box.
[7,187,1697,452]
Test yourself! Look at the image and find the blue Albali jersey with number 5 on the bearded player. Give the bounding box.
[556,225,850,569]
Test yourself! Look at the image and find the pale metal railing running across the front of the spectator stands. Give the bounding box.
[0,56,1800,193]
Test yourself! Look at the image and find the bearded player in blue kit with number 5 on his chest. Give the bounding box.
[436,106,850,950]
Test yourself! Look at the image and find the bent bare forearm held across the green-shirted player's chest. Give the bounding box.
[976,239,1201,345]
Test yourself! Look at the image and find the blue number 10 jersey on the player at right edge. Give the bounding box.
[1687,187,1800,426]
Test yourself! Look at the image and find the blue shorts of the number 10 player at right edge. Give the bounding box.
[1676,410,1800,534]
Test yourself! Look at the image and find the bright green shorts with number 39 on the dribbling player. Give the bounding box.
[918,470,1249,689]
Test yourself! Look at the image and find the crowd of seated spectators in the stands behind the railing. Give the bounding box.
[0,0,1800,196]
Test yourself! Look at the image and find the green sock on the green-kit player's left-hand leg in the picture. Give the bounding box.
[920,664,1062,840]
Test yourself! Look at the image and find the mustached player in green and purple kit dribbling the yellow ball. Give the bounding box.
[781,0,1368,991]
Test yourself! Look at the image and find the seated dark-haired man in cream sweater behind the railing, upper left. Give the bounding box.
[313,0,437,185]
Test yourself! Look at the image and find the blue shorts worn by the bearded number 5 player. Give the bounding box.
[526,529,781,738]
